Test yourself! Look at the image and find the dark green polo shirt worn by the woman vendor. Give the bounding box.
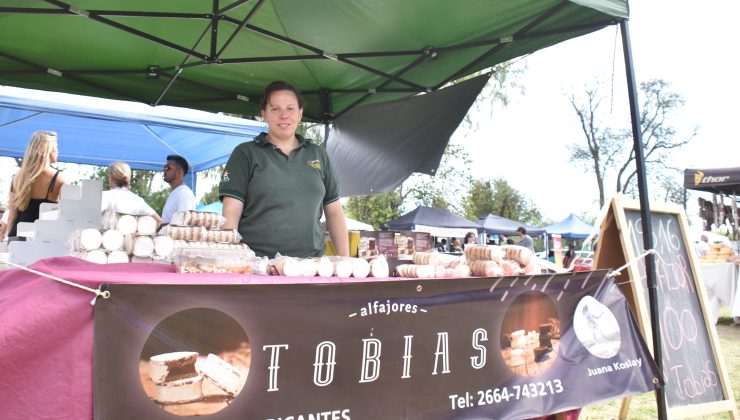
[219,133,339,258]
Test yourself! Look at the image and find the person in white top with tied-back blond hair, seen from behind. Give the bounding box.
[100,162,162,224]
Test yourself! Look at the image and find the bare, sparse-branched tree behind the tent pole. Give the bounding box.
[569,80,697,206]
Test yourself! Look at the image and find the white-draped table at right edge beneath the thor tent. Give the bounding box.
[700,263,740,324]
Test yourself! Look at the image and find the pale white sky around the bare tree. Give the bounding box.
[0,0,740,225]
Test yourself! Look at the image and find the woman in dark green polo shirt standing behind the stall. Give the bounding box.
[219,81,349,258]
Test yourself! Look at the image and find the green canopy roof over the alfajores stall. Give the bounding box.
[0,0,629,121]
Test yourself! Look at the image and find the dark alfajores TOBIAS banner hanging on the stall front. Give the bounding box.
[94,271,663,420]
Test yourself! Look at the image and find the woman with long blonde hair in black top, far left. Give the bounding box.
[0,131,65,241]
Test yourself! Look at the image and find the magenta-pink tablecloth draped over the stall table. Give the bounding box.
[0,257,395,420]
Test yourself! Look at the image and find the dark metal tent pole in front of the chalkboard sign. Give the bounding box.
[619,19,667,420]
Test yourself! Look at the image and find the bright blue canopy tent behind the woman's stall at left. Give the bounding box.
[0,87,266,193]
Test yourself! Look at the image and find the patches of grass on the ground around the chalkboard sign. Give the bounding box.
[580,308,740,420]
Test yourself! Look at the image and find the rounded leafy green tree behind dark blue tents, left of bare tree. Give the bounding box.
[464,178,542,225]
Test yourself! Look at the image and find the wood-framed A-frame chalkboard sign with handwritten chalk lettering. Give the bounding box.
[597,197,736,417]
